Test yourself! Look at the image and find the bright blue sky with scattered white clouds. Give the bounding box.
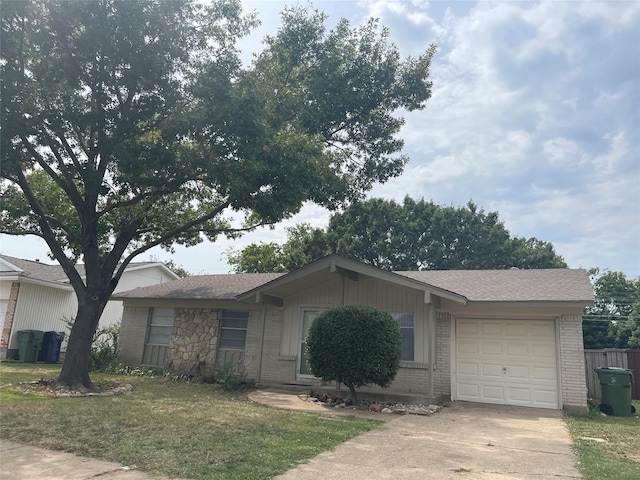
[0,0,640,278]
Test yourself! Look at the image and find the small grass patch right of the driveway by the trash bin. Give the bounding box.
[567,401,640,480]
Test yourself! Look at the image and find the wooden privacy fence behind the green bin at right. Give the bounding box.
[584,348,640,400]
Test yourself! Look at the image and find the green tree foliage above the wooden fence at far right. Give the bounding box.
[582,269,640,349]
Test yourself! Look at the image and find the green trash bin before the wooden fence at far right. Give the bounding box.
[595,367,635,417]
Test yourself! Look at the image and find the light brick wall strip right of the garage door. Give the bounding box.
[558,315,588,413]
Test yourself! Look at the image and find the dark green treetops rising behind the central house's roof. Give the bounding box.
[229,197,567,272]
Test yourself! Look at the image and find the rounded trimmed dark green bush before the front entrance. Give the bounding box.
[305,305,402,401]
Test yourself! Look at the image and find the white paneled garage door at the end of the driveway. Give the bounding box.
[456,319,559,408]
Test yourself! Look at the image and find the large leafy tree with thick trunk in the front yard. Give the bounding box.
[0,0,434,388]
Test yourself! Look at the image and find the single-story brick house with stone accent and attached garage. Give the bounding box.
[114,255,594,412]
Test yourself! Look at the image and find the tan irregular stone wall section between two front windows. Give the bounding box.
[167,308,221,374]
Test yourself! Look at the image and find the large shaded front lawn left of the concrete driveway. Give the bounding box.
[0,364,380,479]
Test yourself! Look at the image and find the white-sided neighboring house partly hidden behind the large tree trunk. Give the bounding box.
[0,255,179,358]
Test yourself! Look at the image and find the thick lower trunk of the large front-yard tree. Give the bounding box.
[56,299,106,391]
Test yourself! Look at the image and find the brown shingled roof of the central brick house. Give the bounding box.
[113,255,593,303]
